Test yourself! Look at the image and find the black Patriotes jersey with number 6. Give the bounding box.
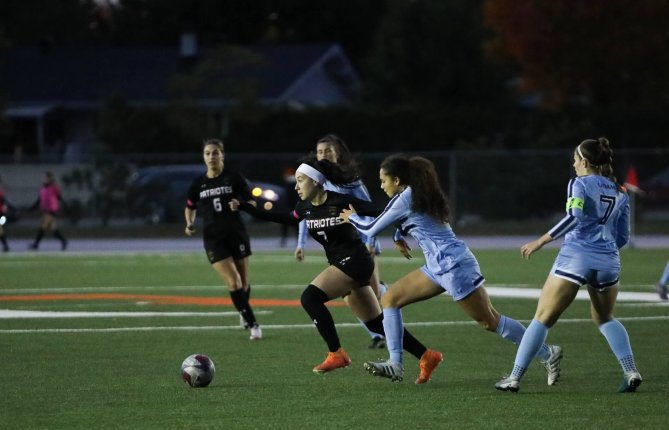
[186,170,252,238]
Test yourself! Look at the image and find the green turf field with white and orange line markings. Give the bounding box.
[0,249,669,429]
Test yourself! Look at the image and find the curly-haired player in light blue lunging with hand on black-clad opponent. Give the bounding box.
[340,155,562,385]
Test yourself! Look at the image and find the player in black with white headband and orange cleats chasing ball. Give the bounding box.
[230,160,434,376]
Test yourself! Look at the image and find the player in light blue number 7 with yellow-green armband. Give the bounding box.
[495,137,641,392]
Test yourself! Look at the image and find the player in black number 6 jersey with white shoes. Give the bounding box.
[185,139,262,340]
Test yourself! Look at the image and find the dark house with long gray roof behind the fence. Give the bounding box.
[0,40,361,161]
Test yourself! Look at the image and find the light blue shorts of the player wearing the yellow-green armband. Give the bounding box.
[550,249,620,290]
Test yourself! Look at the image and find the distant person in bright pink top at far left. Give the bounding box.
[28,172,68,251]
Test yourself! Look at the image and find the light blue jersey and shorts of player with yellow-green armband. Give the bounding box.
[548,175,630,288]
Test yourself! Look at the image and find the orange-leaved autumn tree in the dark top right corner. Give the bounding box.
[484,0,669,107]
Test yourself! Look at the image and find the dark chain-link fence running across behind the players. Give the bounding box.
[0,148,669,228]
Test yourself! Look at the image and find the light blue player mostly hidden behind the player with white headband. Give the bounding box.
[295,134,386,349]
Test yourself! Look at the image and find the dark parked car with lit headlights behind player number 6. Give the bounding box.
[127,164,291,224]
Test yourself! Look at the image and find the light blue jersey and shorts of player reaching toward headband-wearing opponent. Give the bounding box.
[349,187,484,300]
